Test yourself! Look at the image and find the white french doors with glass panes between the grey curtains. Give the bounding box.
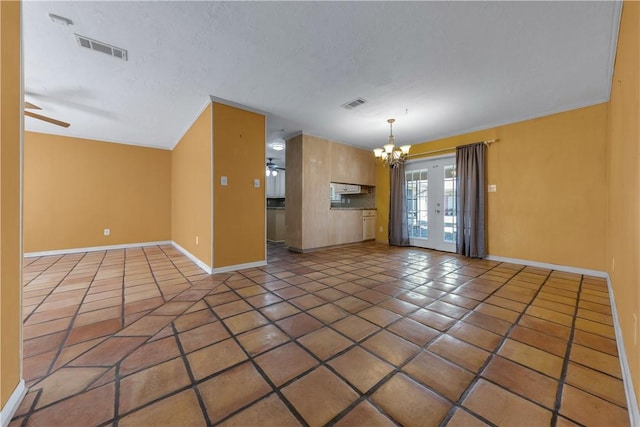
[405,156,457,252]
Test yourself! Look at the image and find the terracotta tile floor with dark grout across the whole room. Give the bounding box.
[10,243,629,427]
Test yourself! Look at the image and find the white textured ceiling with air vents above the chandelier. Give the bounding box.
[23,0,621,163]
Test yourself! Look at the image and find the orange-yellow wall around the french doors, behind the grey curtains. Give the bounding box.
[376,104,607,271]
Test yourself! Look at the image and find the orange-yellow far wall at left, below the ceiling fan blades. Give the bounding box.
[23,132,171,253]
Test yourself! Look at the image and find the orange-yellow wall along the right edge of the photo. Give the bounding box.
[607,1,640,397]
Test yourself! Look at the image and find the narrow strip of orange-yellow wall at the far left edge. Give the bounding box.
[0,1,22,410]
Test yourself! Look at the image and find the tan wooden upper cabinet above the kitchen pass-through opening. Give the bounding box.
[330,143,376,186]
